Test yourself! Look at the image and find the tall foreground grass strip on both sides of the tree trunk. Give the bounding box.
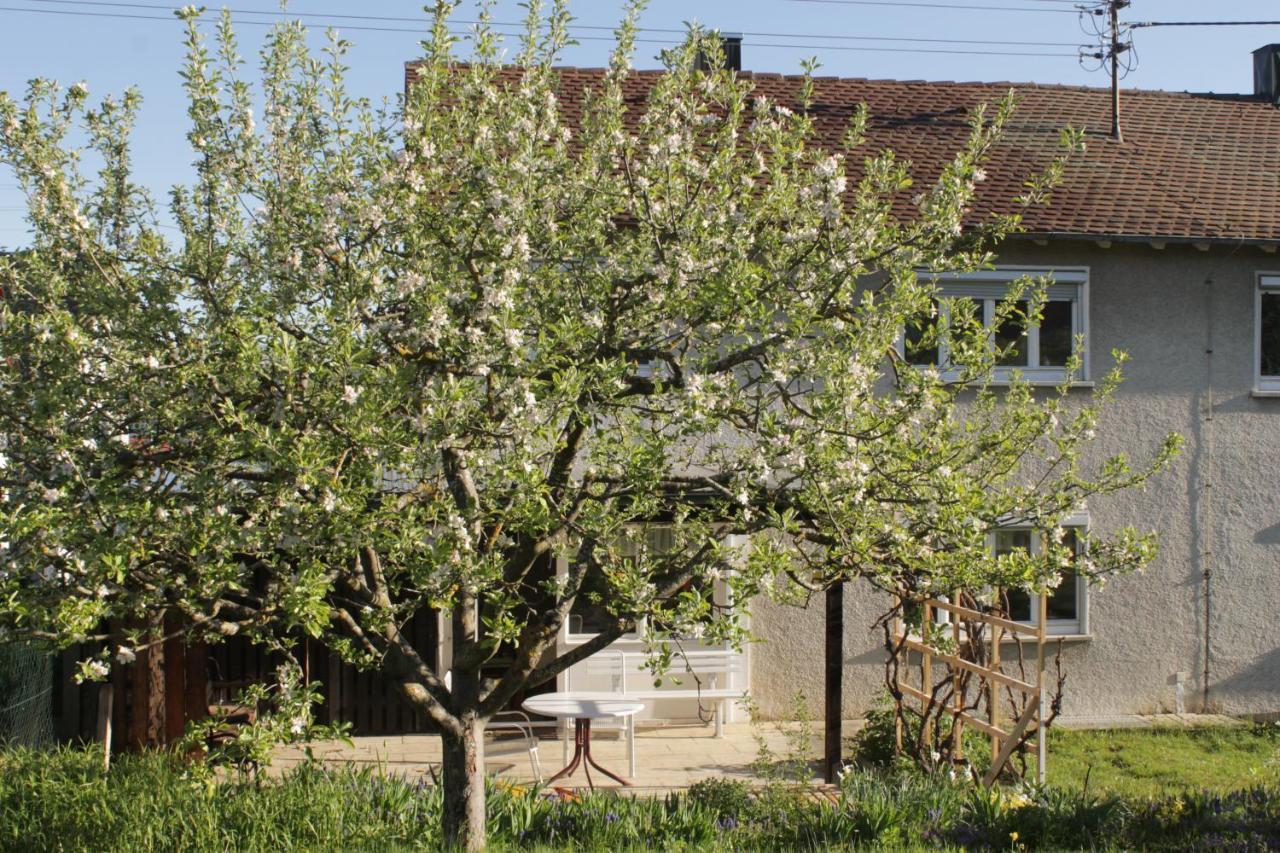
[0,748,1280,853]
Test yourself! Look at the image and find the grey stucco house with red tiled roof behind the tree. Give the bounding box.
[406,38,1280,719]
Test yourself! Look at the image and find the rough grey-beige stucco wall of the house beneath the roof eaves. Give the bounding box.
[751,242,1280,716]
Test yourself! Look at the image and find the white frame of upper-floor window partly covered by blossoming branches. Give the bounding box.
[902,266,1091,386]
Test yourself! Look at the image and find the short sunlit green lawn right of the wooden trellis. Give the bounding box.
[1048,724,1280,797]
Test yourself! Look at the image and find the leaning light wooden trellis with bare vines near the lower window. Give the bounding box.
[892,594,1047,786]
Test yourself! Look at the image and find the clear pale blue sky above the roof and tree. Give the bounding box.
[0,0,1280,247]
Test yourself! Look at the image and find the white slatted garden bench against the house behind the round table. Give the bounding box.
[567,649,746,738]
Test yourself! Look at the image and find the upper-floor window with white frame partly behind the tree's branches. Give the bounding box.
[902,268,1089,383]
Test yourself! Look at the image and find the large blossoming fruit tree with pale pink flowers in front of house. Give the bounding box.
[0,3,1175,848]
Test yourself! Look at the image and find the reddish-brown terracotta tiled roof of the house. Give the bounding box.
[407,65,1280,242]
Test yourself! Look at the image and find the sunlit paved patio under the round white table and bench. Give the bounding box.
[273,720,861,792]
